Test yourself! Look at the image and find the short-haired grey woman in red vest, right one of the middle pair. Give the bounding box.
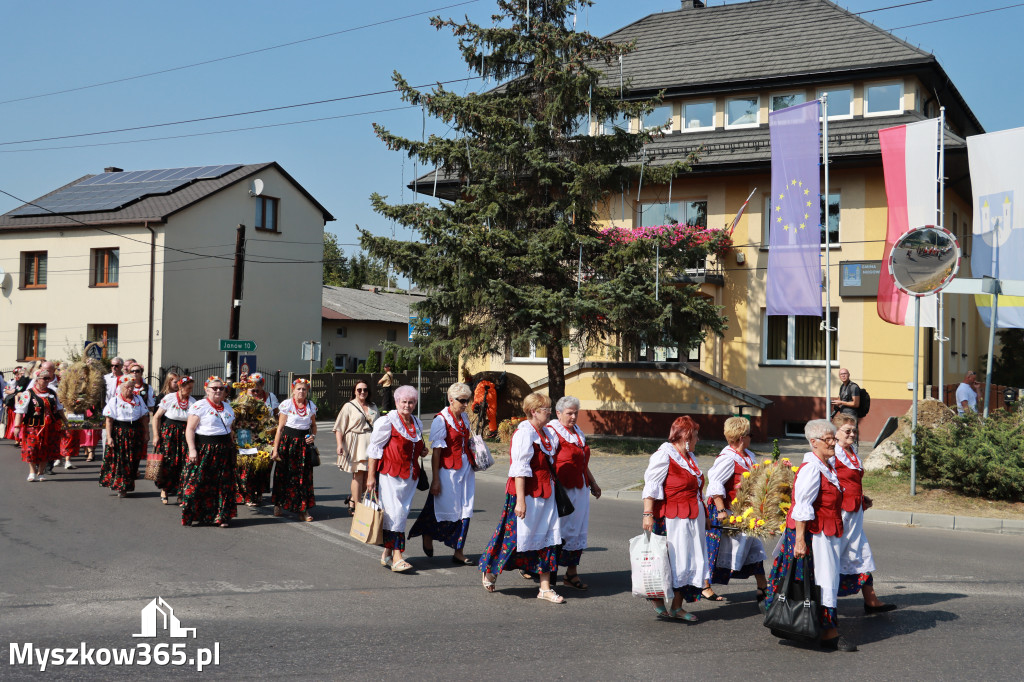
[548,395,601,590]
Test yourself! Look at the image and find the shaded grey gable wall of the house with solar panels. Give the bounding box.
[158,168,324,372]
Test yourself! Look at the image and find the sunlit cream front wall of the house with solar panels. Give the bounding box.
[0,225,160,369]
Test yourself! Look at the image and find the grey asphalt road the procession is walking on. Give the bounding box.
[0,441,1024,680]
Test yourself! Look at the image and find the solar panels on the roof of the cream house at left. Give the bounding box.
[9,164,242,216]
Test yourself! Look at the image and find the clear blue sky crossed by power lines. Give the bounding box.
[0,0,1024,262]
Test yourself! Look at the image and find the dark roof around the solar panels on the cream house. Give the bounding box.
[0,162,334,231]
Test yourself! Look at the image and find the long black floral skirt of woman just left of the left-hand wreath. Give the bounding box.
[180,435,238,525]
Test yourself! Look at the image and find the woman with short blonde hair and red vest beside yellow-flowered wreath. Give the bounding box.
[701,417,768,609]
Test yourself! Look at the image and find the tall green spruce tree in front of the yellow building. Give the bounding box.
[360,0,727,399]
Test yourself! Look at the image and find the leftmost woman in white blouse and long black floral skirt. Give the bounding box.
[99,375,150,498]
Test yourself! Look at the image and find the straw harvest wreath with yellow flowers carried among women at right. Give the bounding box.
[723,458,797,538]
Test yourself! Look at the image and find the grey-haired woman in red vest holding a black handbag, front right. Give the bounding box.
[765,419,857,651]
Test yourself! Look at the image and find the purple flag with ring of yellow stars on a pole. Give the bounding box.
[765,100,821,317]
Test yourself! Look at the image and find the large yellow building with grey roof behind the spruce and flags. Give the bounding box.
[430,0,987,439]
